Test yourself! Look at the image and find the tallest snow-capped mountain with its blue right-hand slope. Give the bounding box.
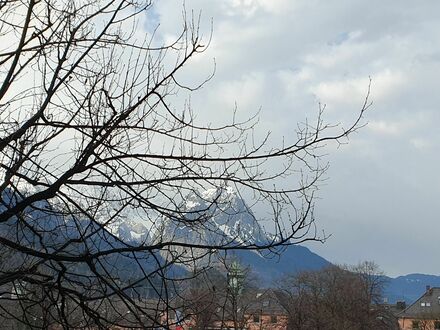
[157,187,330,285]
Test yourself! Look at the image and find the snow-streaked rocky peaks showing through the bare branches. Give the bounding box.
[108,187,269,246]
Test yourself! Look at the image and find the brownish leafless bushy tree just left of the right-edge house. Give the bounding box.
[281,262,397,330]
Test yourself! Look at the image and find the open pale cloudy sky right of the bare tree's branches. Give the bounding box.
[148,0,440,276]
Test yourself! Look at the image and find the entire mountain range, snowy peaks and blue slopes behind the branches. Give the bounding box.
[4,188,440,303]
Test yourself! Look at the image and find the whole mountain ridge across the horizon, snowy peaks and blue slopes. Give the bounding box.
[0,189,440,303]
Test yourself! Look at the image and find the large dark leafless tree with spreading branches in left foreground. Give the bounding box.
[0,0,369,329]
